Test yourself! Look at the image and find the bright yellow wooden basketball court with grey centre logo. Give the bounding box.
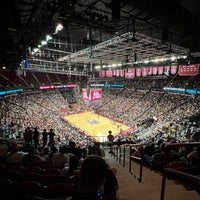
[63,112,131,142]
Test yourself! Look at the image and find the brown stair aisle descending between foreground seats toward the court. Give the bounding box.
[105,150,200,200]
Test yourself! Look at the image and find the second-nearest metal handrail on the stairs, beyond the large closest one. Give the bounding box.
[129,144,144,183]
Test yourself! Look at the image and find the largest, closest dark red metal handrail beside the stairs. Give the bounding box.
[160,142,200,200]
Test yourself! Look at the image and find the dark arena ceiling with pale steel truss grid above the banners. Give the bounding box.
[0,0,200,70]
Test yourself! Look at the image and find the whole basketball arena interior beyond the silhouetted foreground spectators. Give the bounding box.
[0,0,200,200]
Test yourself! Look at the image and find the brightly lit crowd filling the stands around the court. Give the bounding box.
[0,72,200,145]
